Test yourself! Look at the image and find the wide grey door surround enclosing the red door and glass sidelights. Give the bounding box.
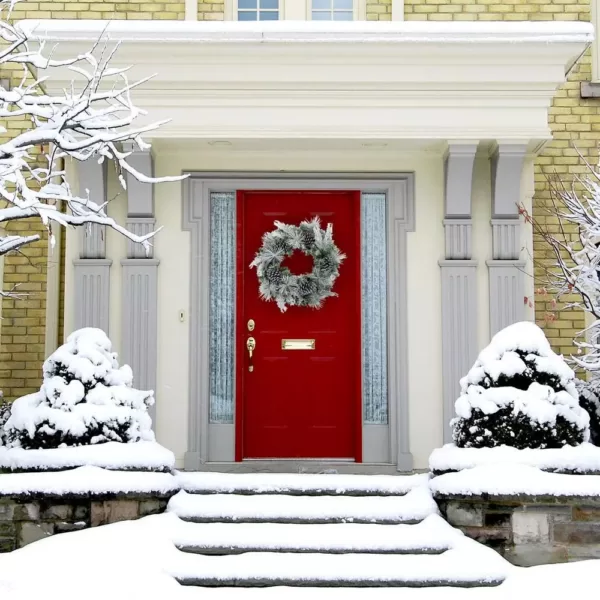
[182,171,415,472]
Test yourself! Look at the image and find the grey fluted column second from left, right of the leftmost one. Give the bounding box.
[121,146,159,421]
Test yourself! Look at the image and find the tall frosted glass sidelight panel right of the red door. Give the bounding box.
[361,193,388,424]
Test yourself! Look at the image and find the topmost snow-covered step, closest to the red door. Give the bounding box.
[176,472,429,496]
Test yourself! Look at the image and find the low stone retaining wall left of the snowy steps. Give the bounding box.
[0,494,168,552]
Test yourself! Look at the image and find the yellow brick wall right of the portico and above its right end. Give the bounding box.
[404,0,600,355]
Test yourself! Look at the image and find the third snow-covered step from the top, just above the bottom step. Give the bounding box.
[173,515,454,555]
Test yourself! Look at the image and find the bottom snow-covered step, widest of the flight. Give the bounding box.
[169,548,508,587]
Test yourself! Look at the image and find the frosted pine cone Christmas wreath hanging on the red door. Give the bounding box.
[250,217,346,312]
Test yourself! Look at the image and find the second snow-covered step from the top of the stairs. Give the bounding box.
[168,487,438,524]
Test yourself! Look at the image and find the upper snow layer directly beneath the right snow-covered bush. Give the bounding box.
[429,443,600,473]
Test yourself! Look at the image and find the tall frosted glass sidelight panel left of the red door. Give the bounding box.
[209,192,235,423]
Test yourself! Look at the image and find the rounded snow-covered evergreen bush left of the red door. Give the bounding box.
[4,328,154,449]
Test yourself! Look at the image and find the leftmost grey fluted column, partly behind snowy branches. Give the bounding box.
[73,158,112,334]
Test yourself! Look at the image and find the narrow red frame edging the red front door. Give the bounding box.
[234,186,364,464]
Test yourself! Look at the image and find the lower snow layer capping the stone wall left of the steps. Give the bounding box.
[0,467,179,497]
